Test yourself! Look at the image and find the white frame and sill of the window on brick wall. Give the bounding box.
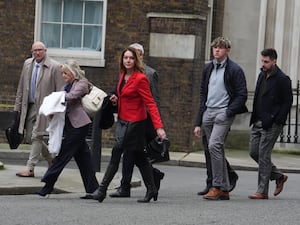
[34,0,107,67]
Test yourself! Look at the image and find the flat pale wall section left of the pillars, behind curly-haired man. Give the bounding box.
[223,0,260,91]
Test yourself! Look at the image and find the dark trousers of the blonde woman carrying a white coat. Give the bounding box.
[42,117,99,193]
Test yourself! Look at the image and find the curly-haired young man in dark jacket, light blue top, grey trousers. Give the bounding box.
[194,37,248,200]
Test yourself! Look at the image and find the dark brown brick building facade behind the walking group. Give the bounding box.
[0,0,224,152]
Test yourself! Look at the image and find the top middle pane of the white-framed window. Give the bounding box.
[63,0,83,23]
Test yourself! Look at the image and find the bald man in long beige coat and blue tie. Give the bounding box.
[14,41,64,177]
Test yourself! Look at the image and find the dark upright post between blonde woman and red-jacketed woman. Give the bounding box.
[91,110,102,172]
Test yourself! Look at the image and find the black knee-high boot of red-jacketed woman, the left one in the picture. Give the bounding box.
[93,164,118,202]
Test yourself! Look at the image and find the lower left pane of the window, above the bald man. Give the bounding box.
[41,24,60,48]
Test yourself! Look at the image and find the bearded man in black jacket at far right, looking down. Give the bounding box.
[248,48,293,199]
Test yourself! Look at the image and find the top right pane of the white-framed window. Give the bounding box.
[84,2,103,24]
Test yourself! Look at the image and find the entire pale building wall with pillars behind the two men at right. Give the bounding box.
[223,0,300,146]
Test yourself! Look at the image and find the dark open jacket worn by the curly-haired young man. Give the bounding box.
[195,58,248,126]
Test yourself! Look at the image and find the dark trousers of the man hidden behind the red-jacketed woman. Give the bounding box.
[121,116,161,188]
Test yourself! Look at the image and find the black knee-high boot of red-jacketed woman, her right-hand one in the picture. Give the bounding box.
[138,163,158,203]
